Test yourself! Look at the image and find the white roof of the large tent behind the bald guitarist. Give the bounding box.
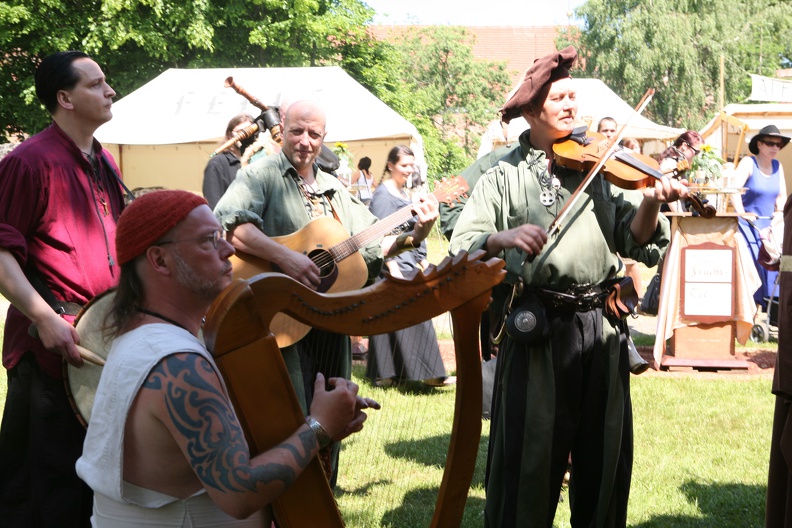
[96,66,420,145]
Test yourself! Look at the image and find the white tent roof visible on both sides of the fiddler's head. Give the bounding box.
[478,79,685,157]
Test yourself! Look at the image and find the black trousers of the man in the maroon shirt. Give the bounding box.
[0,353,93,528]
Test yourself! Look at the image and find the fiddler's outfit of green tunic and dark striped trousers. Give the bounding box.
[451,131,669,528]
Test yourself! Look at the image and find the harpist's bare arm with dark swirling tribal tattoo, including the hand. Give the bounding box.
[124,353,364,518]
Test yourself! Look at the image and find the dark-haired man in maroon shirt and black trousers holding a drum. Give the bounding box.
[0,51,124,527]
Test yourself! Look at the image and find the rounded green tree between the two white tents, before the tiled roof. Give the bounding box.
[380,26,510,174]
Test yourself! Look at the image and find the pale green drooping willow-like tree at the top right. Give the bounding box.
[559,0,792,129]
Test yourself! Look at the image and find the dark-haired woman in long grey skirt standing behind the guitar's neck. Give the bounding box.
[366,145,446,386]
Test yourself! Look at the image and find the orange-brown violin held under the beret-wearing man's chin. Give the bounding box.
[553,130,716,218]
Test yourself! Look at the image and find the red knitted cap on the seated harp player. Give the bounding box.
[116,190,207,266]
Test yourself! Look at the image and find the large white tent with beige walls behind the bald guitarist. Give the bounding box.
[96,66,425,192]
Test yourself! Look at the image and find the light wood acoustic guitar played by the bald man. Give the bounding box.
[231,177,469,348]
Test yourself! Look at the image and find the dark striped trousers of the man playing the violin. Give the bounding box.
[485,309,633,528]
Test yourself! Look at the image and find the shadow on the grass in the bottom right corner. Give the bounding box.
[631,480,767,528]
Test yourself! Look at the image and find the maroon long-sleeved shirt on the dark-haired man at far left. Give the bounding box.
[0,123,124,378]
